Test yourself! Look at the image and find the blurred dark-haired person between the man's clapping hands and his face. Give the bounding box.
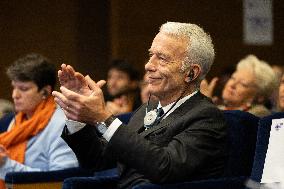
[106,60,141,114]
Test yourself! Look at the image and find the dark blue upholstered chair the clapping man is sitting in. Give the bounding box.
[63,110,259,189]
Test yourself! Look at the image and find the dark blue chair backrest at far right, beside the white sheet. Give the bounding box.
[250,112,284,182]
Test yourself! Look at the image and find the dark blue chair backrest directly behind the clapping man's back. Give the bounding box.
[223,110,259,176]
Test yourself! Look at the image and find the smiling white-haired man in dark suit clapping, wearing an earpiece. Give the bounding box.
[52,22,228,188]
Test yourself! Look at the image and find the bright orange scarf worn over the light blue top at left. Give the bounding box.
[0,97,56,189]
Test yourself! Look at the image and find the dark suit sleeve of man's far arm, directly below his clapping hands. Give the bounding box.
[61,125,116,171]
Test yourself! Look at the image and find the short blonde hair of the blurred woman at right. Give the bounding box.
[237,55,278,97]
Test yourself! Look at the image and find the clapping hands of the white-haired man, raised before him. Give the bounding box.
[52,64,111,124]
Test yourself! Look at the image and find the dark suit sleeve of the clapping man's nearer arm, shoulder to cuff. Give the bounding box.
[109,108,226,183]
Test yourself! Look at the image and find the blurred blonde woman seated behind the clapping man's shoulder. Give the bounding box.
[201,55,277,117]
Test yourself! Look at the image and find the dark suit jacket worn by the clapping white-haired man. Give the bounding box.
[62,93,227,188]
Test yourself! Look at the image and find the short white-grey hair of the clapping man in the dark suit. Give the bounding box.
[160,22,215,81]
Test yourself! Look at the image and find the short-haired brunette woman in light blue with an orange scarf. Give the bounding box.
[0,54,78,189]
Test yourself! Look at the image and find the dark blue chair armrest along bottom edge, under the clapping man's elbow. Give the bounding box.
[133,177,247,189]
